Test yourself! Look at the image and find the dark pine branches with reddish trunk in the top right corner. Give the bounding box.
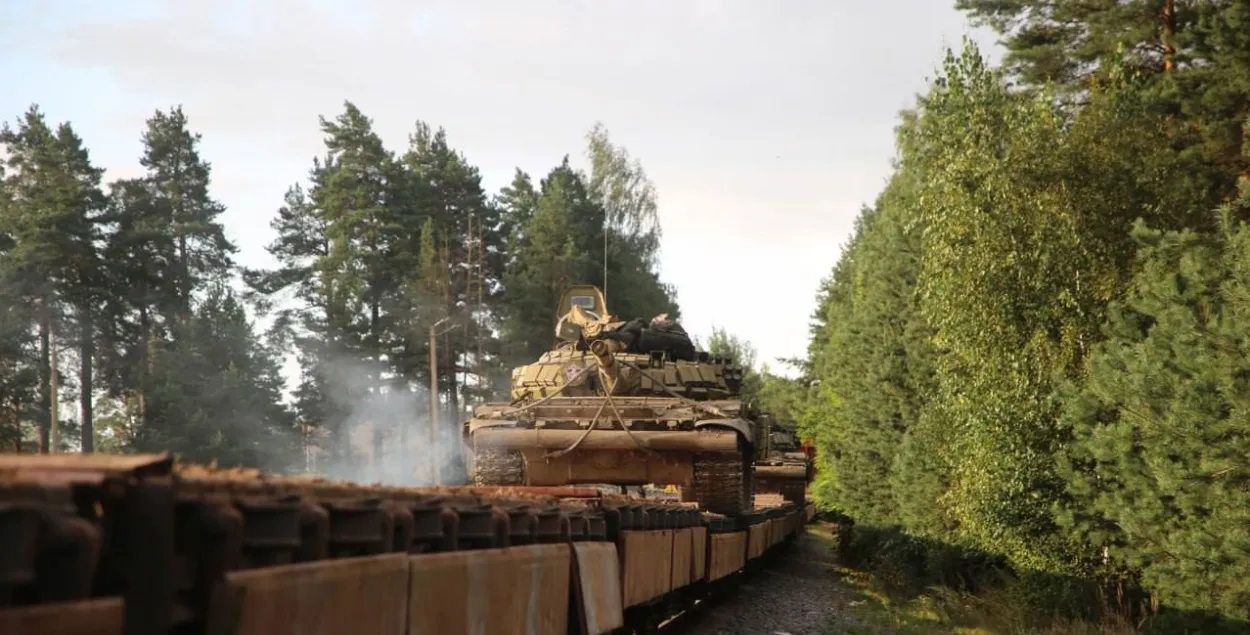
[955,0,1250,198]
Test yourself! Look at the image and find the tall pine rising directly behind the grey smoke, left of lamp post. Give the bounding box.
[244,103,421,475]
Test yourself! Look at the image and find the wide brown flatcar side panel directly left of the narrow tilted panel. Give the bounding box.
[407,545,573,635]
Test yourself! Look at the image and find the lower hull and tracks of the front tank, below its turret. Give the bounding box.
[464,395,754,515]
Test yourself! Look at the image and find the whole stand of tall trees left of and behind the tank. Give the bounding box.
[0,103,678,481]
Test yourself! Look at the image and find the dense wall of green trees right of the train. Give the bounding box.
[773,0,1250,633]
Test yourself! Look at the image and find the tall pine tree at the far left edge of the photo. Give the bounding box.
[0,106,104,450]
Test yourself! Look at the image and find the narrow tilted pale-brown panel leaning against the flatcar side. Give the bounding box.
[573,543,625,635]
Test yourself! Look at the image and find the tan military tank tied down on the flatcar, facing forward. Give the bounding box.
[463,285,761,515]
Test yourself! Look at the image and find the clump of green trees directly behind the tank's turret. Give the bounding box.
[500,135,680,364]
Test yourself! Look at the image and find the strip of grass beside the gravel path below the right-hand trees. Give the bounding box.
[809,524,1135,635]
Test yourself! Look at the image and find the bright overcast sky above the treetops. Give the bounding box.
[0,0,993,377]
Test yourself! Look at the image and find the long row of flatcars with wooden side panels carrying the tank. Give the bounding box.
[0,455,814,635]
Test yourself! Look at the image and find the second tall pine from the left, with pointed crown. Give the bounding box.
[96,108,236,447]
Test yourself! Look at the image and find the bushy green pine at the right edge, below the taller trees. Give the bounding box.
[1064,201,1250,619]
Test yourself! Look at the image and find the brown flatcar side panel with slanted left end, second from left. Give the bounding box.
[208,554,409,635]
